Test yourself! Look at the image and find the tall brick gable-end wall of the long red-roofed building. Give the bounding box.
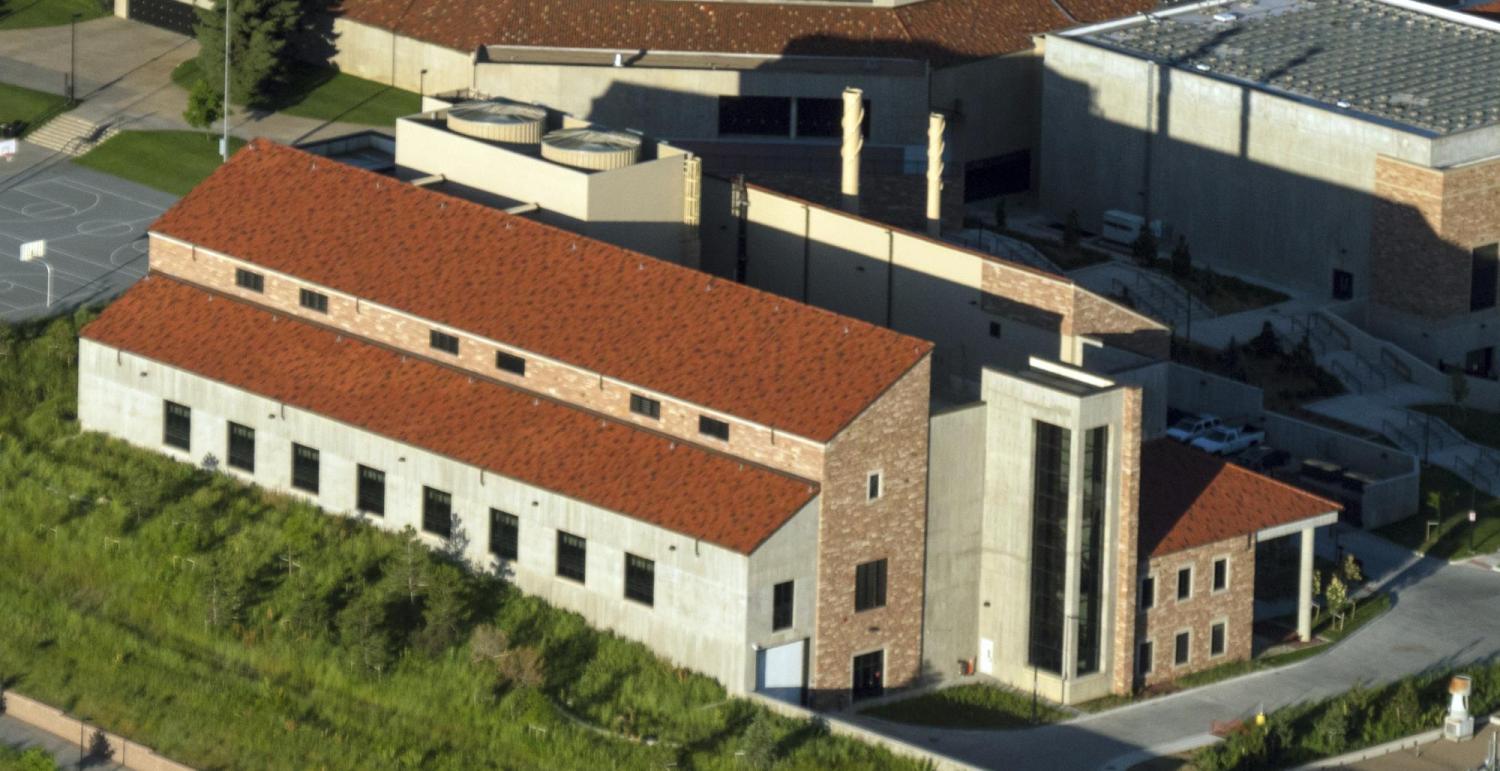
[810,356,932,708]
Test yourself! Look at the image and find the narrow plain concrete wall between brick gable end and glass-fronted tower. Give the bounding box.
[923,404,990,678]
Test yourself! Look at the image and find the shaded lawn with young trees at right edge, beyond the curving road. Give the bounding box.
[1376,465,1500,560]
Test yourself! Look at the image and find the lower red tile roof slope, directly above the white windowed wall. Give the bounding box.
[81,273,816,554]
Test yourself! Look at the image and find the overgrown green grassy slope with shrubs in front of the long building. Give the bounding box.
[0,311,920,771]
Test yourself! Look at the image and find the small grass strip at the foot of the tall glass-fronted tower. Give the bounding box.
[860,683,1073,729]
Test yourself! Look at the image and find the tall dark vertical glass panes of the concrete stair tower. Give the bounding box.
[1028,422,1109,675]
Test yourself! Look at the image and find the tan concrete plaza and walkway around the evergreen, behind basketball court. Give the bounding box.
[0,17,395,144]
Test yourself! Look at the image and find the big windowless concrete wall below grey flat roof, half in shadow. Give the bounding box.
[1041,36,1433,296]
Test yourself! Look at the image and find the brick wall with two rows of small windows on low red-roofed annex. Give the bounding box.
[1136,537,1256,686]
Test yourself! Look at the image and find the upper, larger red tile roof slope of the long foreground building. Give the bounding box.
[152,140,932,441]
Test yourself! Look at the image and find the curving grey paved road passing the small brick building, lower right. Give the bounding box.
[854,537,1500,770]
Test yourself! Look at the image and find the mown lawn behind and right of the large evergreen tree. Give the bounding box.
[173,59,422,126]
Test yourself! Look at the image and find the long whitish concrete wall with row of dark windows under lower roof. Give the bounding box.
[78,341,798,692]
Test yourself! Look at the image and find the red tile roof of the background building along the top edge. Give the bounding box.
[341,0,1155,66]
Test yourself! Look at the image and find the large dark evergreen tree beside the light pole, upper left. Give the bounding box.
[194,0,303,107]
